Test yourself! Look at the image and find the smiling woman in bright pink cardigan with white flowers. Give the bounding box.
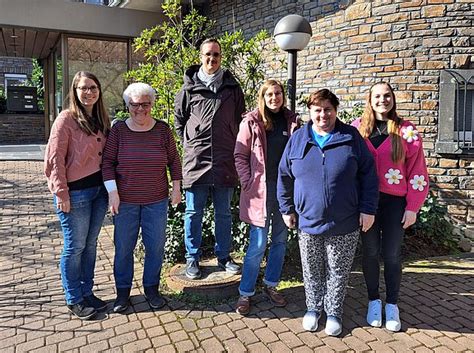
[353,82,429,331]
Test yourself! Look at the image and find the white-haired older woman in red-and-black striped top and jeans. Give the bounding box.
[102,83,182,312]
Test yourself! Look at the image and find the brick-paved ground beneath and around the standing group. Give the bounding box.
[0,161,474,353]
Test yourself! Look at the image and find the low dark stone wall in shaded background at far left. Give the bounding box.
[0,114,46,145]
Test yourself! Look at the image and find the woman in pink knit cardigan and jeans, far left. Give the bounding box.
[44,71,110,320]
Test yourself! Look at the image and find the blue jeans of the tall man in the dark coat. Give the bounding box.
[184,185,234,260]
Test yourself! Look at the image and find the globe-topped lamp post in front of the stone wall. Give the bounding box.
[273,15,313,112]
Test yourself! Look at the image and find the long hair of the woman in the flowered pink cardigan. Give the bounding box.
[359,81,405,163]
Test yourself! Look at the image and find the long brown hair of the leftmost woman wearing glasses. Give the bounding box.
[68,71,110,135]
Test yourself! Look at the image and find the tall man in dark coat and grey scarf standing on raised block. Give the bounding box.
[175,38,245,279]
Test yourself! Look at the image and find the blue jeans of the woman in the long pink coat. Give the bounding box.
[239,186,288,296]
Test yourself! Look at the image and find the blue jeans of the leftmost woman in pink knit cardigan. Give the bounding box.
[54,186,108,305]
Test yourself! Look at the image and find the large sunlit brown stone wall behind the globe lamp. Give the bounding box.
[209,0,474,239]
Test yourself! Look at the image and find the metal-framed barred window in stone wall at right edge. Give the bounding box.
[436,69,474,154]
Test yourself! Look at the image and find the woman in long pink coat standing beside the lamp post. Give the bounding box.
[234,80,297,315]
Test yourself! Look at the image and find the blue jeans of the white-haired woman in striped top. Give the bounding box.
[114,199,168,288]
